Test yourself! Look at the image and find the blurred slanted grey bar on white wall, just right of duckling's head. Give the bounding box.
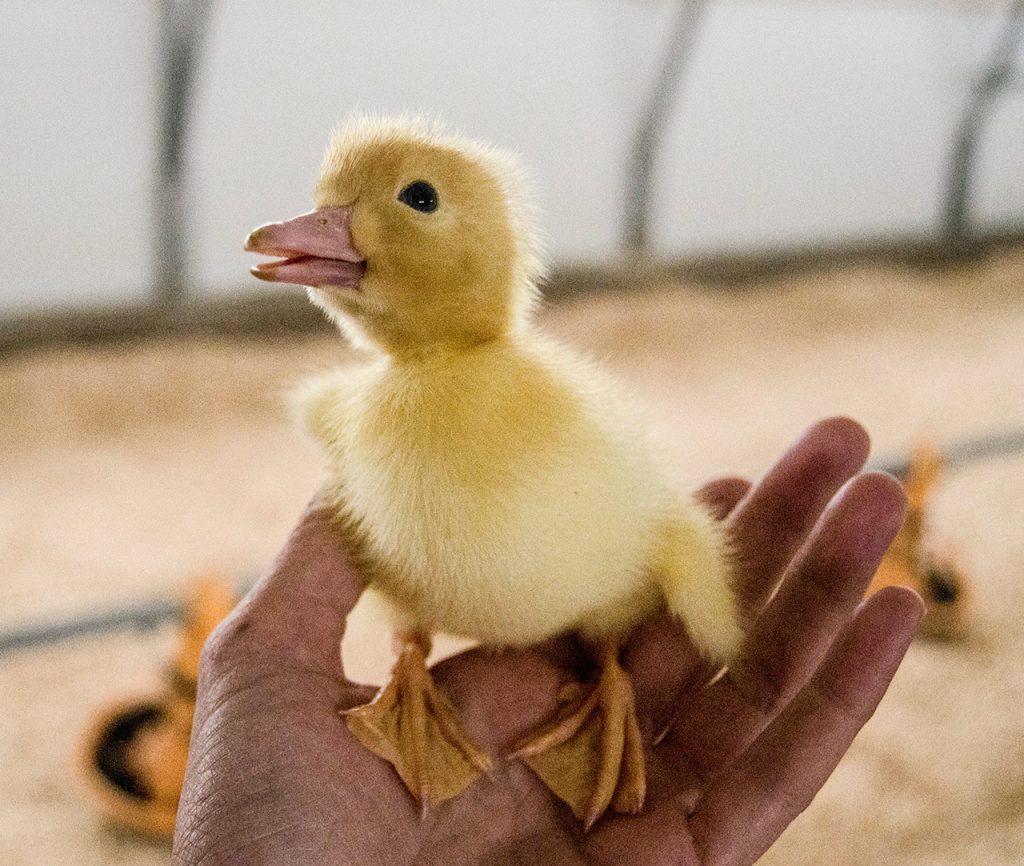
[623,0,708,255]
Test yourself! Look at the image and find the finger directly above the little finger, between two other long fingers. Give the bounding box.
[671,473,906,780]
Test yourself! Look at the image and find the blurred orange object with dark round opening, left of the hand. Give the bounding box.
[80,577,234,839]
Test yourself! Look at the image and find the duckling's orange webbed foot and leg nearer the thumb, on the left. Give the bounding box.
[341,634,490,815]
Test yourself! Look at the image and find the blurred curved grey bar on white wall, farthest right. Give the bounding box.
[942,0,1024,253]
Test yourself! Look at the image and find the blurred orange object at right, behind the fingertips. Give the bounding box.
[867,443,971,639]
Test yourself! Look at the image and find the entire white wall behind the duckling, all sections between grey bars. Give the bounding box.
[0,0,1024,314]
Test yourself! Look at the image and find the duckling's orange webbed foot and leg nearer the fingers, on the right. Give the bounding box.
[511,641,647,830]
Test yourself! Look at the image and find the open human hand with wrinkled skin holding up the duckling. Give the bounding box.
[174,419,923,866]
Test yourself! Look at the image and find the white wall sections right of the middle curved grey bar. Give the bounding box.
[656,2,1024,252]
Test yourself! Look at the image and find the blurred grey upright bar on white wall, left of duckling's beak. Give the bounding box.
[154,0,213,308]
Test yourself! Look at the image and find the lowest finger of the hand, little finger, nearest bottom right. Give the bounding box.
[690,587,925,864]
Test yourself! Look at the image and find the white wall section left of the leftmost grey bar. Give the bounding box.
[0,0,157,314]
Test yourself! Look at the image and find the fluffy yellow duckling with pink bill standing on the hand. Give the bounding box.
[246,119,741,827]
